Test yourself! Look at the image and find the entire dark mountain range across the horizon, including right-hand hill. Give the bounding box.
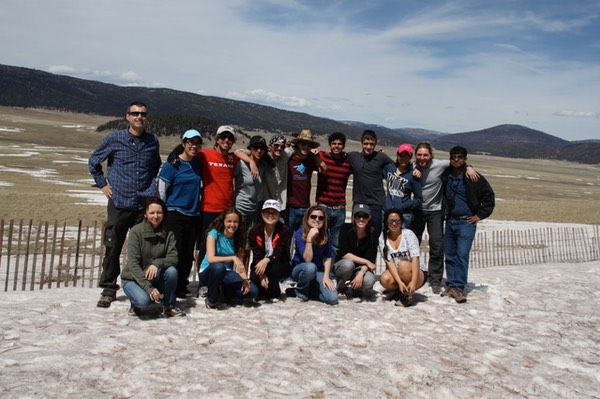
[0,65,600,164]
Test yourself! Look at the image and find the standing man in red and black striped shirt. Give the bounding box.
[315,132,352,263]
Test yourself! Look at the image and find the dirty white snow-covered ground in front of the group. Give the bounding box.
[0,262,600,398]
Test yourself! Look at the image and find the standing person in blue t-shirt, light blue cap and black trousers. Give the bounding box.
[158,129,202,298]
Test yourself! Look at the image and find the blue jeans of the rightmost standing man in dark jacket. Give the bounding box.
[444,219,477,291]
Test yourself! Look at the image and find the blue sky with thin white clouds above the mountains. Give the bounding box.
[0,0,600,140]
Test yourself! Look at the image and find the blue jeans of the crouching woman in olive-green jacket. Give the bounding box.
[123,266,177,309]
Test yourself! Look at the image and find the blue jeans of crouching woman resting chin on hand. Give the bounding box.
[292,262,338,305]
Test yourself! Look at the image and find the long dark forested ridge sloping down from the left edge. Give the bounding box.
[0,65,393,139]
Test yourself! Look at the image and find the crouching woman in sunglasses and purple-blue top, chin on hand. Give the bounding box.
[292,205,338,305]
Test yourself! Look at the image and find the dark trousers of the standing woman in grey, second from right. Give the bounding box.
[412,211,444,284]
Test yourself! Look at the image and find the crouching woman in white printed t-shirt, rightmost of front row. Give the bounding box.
[379,209,427,307]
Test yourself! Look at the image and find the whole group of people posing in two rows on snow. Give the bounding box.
[89,102,494,317]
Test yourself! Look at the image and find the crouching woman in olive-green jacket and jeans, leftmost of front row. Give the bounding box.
[121,198,185,317]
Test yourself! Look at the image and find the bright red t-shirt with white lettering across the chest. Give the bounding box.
[196,149,240,212]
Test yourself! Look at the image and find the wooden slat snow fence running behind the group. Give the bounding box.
[0,219,600,291]
